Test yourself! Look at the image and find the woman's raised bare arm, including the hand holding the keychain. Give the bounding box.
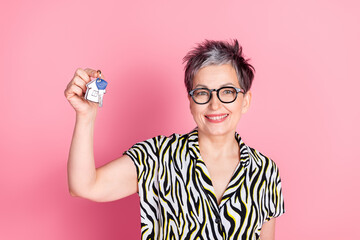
[65,69,137,201]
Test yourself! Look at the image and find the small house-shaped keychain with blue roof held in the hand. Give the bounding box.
[85,70,107,107]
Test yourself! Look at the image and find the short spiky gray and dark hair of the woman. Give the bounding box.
[183,39,255,93]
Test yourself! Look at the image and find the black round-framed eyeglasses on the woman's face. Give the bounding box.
[189,87,245,104]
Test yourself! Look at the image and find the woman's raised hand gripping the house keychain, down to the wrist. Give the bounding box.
[64,68,99,115]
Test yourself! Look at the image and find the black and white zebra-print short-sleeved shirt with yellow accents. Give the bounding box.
[125,129,285,240]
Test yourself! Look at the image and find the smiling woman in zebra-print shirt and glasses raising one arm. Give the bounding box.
[65,40,284,240]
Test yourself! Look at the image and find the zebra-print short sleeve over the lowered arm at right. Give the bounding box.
[265,161,285,221]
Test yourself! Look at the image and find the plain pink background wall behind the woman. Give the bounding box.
[0,0,360,240]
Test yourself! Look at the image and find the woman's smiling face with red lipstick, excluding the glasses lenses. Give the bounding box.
[189,64,251,137]
